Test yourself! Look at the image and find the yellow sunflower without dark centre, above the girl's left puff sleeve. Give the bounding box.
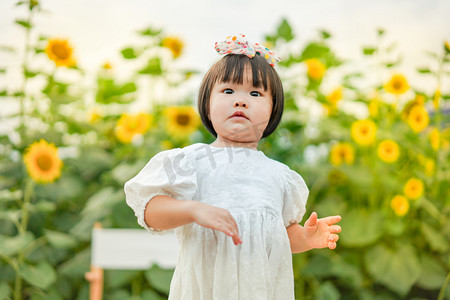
[115,113,152,143]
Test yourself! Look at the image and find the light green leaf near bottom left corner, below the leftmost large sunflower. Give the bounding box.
[19,261,56,290]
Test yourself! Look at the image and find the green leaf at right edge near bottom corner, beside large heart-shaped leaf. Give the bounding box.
[417,254,447,290]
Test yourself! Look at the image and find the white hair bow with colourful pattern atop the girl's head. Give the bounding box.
[214,34,281,67]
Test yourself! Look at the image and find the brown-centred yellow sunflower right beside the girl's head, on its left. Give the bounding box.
[164,106,200,137]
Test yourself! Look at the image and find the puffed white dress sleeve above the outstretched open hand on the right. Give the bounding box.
[282,167,309,227]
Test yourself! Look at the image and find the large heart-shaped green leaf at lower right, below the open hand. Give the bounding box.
[364,244,420,296]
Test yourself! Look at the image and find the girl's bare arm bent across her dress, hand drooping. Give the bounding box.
[144,195,242,245]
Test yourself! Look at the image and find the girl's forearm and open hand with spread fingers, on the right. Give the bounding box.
[286,212,341,253]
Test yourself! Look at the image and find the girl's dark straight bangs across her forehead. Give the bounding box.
[213,54,273,91]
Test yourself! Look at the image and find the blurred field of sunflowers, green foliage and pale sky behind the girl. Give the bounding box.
[0,0,450,300]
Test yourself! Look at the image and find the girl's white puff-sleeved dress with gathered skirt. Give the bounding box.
[125,143,309,300]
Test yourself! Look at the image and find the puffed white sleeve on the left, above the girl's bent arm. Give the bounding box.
[124,148,197,231]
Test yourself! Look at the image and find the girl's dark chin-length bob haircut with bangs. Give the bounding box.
[198,54,284,138]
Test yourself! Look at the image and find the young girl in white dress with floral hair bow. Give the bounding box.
[125,36,341,300]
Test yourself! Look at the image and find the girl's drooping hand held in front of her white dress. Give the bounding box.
[193,201,242,245]
